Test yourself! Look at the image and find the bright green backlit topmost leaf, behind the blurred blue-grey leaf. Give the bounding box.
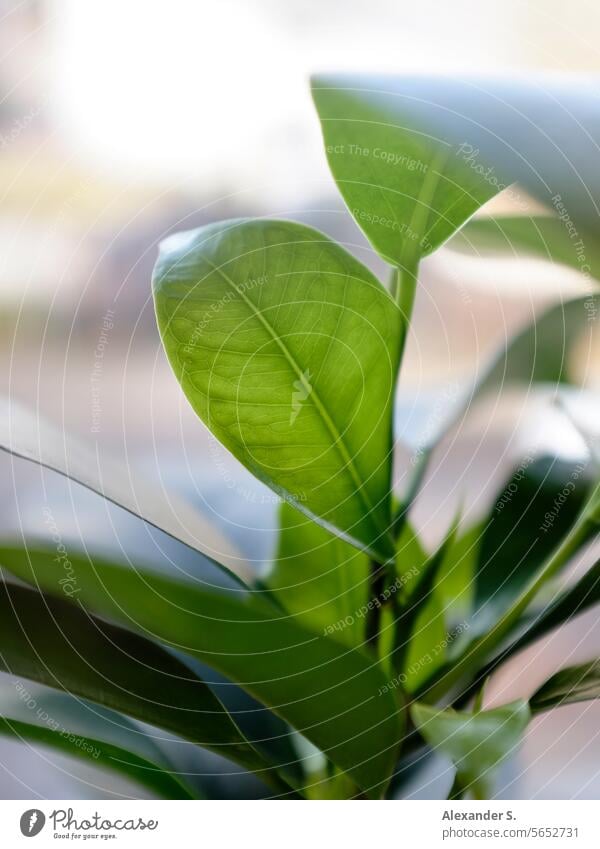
[312,75,499,268]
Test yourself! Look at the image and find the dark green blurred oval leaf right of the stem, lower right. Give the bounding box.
[475,455,591,621]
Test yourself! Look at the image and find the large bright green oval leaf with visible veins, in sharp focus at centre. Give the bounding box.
[153,220,399,560]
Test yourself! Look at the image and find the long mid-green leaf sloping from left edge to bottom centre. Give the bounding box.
[0,549,404,796]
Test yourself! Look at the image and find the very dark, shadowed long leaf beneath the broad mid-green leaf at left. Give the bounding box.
[0,576,276,780]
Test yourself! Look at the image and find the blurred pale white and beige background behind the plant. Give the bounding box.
[0,0,600,798]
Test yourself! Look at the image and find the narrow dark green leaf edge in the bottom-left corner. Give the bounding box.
[0,716,196,799]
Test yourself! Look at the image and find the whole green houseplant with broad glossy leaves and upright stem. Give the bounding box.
[0,78,600,798]
